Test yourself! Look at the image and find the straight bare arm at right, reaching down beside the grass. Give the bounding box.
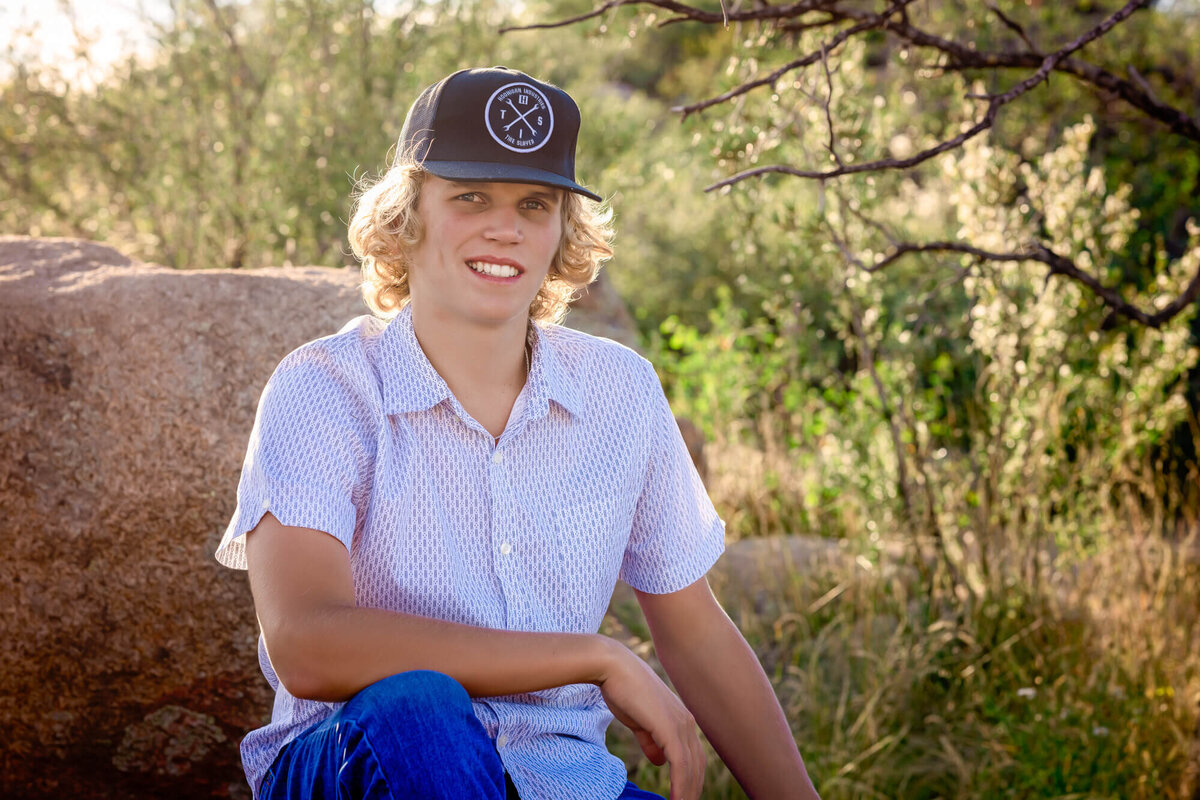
[635,578,817,800]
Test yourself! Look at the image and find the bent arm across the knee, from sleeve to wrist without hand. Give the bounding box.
[246,513,610,700]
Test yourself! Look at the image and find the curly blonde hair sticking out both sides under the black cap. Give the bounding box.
[349,158,613,323]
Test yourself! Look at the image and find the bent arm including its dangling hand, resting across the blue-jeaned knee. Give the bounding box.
[246,513,704,800]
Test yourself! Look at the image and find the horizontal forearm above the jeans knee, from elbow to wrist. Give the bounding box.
[266,607,614,700]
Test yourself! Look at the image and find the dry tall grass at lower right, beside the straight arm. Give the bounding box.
[614,429,1200,800]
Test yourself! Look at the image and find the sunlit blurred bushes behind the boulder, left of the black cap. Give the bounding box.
[0,0,600,267]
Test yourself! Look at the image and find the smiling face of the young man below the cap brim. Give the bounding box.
[408,175,563,325]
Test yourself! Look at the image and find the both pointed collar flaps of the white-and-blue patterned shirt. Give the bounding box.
[379,305,583,419]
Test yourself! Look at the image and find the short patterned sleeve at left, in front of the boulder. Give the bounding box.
[216,343,374,570]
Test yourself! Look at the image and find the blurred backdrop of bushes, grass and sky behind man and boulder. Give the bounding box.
[7,0,1200,799]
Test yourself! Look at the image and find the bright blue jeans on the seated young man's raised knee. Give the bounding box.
[259,669,662,800]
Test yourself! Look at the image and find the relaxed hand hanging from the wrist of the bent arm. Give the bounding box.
[596,639,706,800]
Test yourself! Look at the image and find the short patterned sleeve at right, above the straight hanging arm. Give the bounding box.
[620,359,725,595]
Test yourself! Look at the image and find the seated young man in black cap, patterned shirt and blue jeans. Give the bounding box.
[217,67,816,800]
